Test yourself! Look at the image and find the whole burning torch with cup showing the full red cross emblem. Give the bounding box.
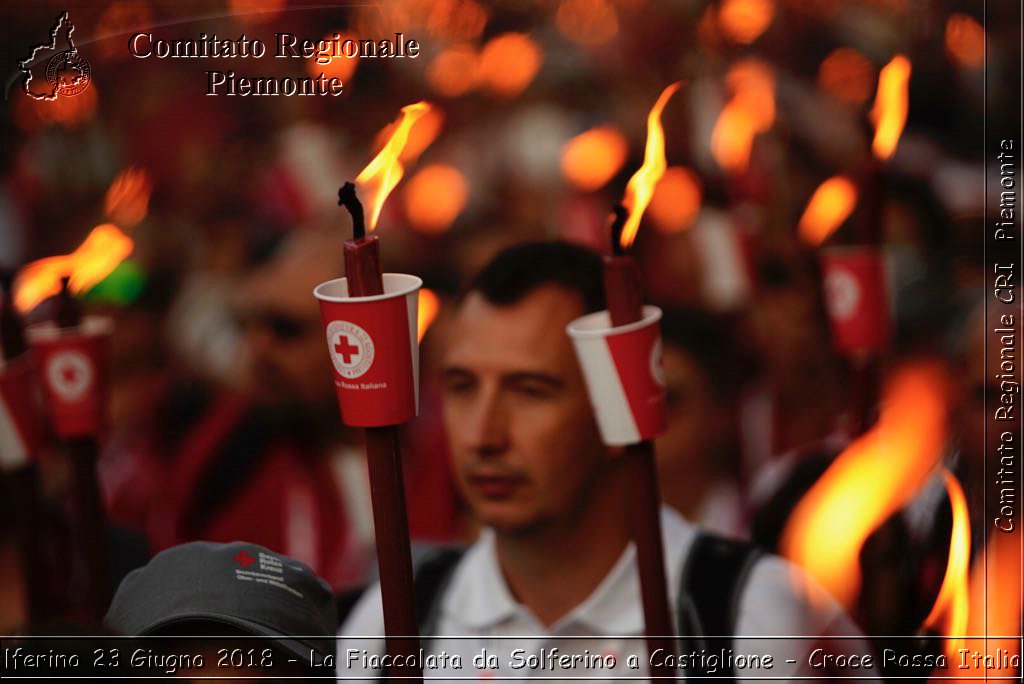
[313,102,430,679]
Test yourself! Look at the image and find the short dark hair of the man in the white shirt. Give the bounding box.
[464,242,604,313]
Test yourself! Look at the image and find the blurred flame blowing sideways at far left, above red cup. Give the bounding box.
[14,223,134,311]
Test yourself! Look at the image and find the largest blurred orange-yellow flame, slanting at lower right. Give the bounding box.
[781,365,947,608]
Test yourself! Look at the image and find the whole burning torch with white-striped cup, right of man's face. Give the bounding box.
[568,82,680,677]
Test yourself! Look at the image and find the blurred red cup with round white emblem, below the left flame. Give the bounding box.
[27,316,114,439]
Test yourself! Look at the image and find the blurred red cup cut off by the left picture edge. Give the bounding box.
[0,354,43,470]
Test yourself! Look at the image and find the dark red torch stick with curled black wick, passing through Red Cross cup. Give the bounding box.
[338,183,423,680]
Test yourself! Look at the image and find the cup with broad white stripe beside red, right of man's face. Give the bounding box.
[566,306,668,446]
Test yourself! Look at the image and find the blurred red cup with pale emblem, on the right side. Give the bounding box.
[820,247,891,354]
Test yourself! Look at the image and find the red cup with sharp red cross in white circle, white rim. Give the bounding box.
[313,273,423,427]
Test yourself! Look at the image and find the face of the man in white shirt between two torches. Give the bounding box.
[443,286,608,535]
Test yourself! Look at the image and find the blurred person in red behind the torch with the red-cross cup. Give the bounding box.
[99,228,372,586]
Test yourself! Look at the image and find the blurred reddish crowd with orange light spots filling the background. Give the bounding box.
[0,0,1019,671]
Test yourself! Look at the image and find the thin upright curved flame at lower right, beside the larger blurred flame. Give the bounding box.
[924,469,971,654]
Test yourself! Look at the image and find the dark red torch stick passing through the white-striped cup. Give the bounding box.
[604,206,676,677]
